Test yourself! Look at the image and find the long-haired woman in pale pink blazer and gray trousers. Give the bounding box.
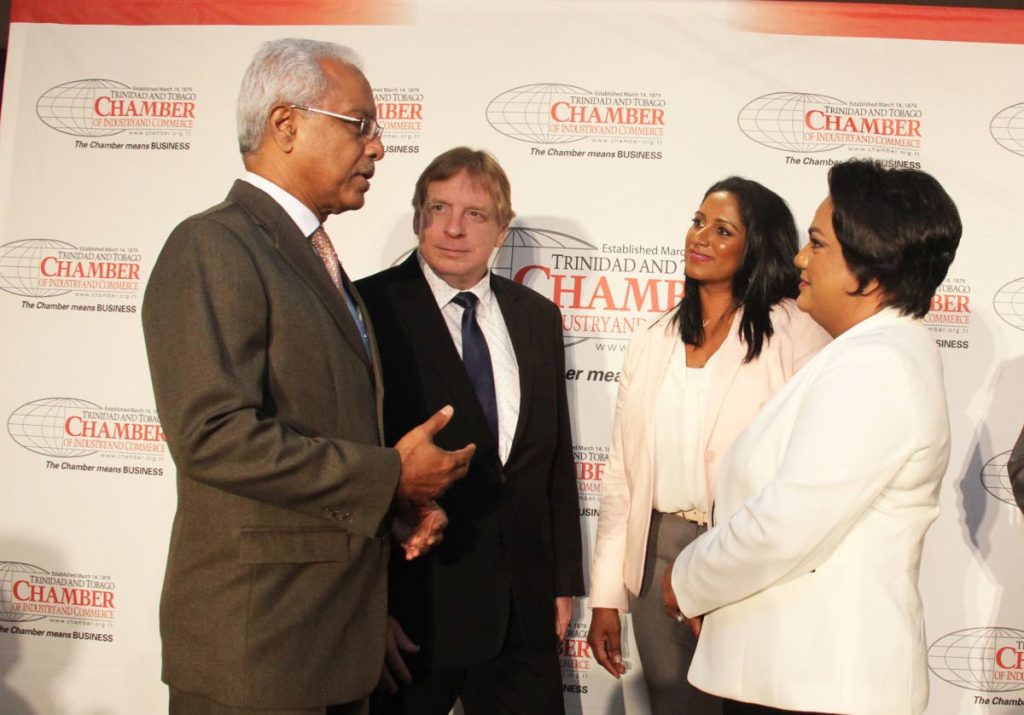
[589,177,828,715]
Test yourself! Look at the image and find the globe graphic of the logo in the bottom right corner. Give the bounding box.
[928,628,1024,692]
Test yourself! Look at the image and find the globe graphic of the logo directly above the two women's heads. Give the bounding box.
[736,92,846,153]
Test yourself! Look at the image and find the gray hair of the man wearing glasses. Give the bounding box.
[236,37,359,154]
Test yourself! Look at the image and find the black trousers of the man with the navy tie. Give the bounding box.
[371,602,565,715]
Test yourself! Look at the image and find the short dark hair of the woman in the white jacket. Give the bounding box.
[828,160,964,318]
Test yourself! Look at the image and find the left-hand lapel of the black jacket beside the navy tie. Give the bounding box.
[388,252,494,443]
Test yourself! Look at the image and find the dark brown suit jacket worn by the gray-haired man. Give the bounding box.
[140,181,400,708]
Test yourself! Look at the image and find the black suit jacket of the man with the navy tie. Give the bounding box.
[357,253,583,666]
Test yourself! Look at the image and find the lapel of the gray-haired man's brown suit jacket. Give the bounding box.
[227,180,370,366]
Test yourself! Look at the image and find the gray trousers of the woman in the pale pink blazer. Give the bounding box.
[630,511,722,715]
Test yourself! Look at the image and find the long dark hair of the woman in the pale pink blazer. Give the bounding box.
[672,176,800,363]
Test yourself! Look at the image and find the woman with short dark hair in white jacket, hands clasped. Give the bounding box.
[664,161,961,715]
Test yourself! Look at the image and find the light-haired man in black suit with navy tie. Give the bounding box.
[357,148,583,715]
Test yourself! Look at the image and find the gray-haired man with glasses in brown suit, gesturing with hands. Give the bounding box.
[142,40,473,715]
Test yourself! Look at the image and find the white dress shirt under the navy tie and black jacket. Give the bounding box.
[416,251,520,464]
